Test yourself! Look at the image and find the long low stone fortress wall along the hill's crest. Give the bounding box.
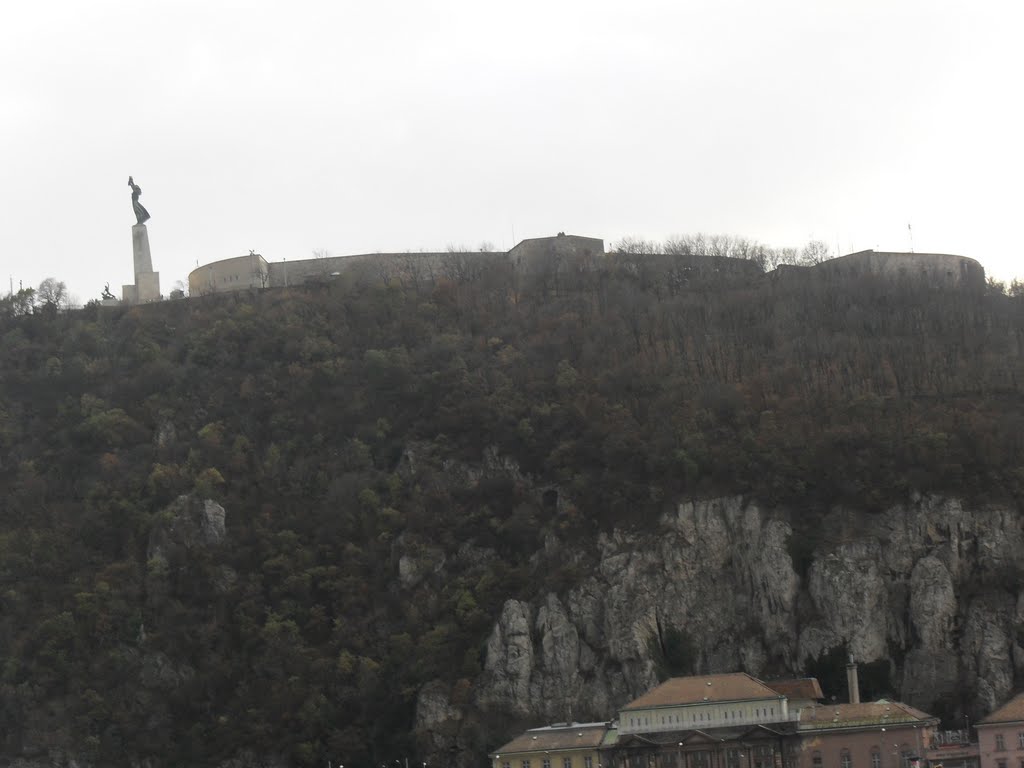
[188,233,985,296]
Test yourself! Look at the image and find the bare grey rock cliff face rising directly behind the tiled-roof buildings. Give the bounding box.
[406,498,1024,765]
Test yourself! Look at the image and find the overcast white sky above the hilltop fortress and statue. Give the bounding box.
[0,0,1024,302]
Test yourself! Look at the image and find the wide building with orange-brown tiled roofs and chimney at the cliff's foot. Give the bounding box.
[493,665,942,768]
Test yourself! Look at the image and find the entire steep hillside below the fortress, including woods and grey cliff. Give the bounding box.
[0,259,1024,768]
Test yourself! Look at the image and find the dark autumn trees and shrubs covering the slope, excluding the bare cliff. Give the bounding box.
[0,257,1024,766]
